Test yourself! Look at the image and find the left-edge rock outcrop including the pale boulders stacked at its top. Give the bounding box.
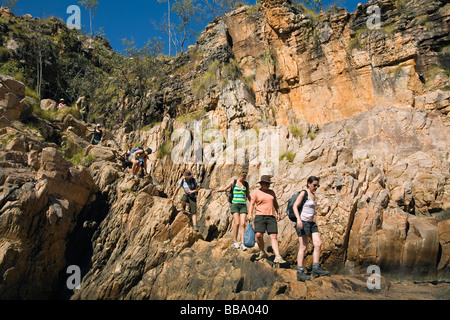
[0,87,99,299]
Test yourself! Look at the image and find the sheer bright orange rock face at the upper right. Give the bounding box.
[220,0,449,125]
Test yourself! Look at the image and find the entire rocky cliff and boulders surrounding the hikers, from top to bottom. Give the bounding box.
[0,0,450,299]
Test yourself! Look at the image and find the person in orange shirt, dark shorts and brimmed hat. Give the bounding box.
[248,176,286,263]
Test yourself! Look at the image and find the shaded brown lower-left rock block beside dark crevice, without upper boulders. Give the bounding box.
[0,148,98,299]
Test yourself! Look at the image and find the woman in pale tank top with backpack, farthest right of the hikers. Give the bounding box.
[293,176,330,281]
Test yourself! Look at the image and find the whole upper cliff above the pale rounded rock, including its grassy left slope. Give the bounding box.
[140,0,449,128]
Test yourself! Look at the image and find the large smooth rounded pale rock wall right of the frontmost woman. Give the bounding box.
[275,108,449,277]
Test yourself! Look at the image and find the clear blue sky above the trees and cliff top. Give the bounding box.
[14,0,367,55]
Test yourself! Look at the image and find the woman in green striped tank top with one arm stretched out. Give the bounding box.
[211,171,250,251]
